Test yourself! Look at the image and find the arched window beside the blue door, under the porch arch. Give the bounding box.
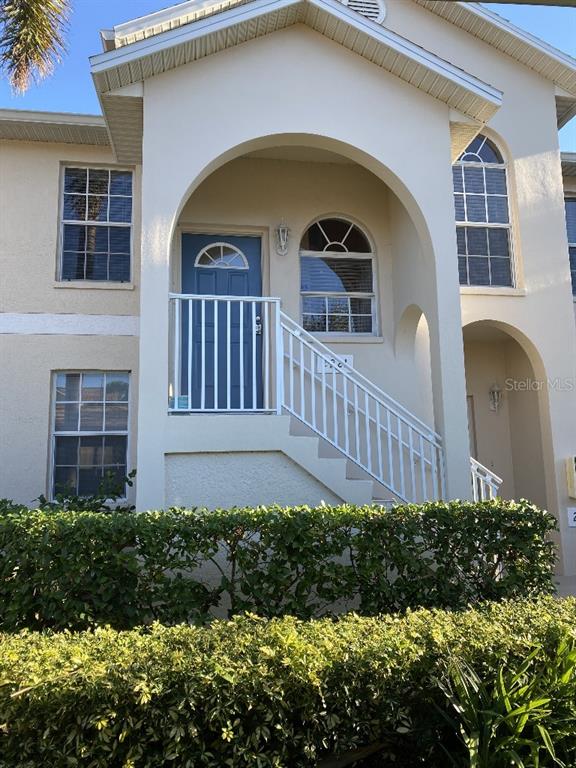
[300,219,375,334]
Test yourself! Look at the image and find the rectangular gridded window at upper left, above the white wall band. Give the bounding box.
[60,167,132,282]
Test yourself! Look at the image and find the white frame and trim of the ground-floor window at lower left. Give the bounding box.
[46,368,132,504]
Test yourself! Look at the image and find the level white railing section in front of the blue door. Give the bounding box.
[168,293,282,413]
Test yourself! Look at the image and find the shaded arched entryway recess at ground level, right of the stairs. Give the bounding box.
[463,320,548,507]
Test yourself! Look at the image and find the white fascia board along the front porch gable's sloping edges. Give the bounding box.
[90,0,503,107]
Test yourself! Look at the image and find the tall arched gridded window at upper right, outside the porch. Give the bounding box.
[452,135,514,287]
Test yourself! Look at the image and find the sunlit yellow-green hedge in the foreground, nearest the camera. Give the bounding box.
[0,597,576,768]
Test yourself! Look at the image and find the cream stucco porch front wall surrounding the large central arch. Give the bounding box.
[138,25,470,506]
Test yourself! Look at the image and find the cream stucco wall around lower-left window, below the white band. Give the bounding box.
[0,334,138,504]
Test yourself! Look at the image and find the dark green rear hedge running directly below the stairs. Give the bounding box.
[0,501,555,630]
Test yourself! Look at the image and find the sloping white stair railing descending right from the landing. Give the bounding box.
[281,312,444,502]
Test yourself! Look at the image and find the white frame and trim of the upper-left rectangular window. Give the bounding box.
[55,161,136,289]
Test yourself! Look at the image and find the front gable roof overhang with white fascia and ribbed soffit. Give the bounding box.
[90,0,502,162]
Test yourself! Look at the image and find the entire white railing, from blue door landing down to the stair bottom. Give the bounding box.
[169,294,502,503]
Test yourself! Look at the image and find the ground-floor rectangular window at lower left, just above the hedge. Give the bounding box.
[52,371,130,496]
